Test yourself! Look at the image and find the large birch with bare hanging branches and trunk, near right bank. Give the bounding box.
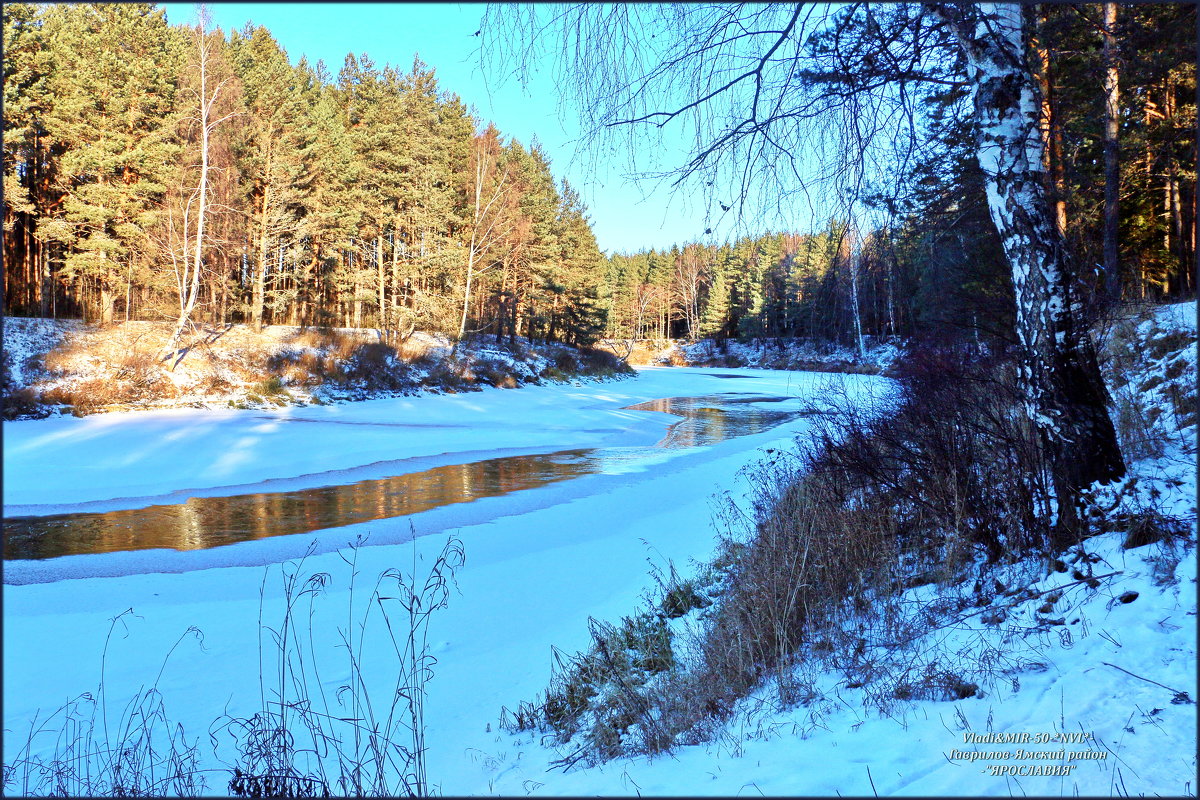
[484,2,1124,530]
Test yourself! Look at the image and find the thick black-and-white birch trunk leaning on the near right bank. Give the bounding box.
[938,4,1124,536]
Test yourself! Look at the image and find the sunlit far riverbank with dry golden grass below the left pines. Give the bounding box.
[0,318,632,420]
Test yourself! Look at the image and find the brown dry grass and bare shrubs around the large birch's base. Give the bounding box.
[502,299,1195,769]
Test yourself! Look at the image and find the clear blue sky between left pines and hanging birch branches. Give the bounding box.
[161,2,724,253]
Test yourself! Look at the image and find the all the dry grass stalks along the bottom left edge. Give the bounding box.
[4,539,464,798]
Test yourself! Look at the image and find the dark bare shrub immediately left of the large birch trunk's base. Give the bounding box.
[810,350,1050,563]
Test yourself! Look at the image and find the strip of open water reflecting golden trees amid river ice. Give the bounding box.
[4,395,796,559]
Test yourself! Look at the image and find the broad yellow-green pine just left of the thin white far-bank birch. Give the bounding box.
[40,4,179,323]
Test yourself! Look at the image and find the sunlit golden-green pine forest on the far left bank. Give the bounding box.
[4,4,604,342]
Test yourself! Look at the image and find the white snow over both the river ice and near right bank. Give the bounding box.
[4,303,1196,796]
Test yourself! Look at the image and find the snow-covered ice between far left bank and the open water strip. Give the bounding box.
[4,369,772,516]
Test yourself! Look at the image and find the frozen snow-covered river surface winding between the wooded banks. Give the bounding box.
[4,368,883,794]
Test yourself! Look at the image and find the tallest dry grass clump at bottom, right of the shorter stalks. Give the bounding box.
[216,539,464,796]
